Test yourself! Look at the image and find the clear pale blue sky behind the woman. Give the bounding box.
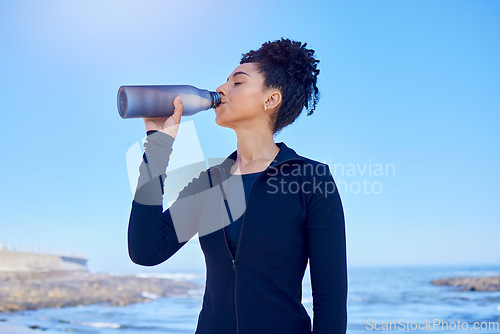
[0,0,500,272]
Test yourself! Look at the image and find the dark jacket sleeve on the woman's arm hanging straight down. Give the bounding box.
[306,165,347,334]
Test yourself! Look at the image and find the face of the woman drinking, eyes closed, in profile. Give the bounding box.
[215,63,270,130]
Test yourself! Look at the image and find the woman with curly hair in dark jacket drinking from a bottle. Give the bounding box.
[128,38,347,334]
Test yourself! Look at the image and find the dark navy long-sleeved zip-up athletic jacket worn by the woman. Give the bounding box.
[128,131,347,334]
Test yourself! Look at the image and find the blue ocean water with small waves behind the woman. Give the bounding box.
[0,265,500,334]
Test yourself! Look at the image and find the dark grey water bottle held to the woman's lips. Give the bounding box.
[117,85,220,118]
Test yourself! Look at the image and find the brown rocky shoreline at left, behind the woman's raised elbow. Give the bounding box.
[0,271,203,313]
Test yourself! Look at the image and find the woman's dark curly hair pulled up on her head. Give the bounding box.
[240,37,319,135]
